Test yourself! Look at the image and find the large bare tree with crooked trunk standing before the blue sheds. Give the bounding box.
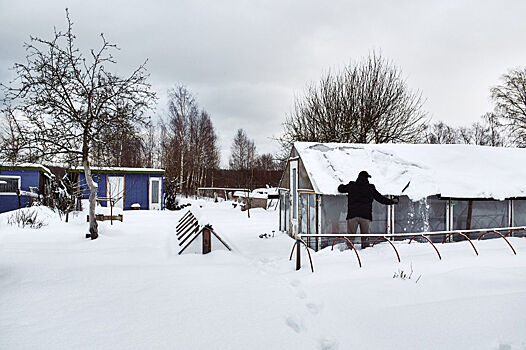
[2,10,155,239]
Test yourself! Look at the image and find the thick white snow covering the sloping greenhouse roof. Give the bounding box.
[294,142,526,200]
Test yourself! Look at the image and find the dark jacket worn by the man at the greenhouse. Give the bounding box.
[338,176,395,220]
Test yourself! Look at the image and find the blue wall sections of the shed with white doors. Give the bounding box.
[79,172,164,210]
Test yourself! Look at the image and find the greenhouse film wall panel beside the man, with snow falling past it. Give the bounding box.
[394,196,446,242]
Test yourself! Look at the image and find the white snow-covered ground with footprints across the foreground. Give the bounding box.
[0,200,526,350]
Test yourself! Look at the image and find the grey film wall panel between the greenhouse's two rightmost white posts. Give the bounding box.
[453,200,508,239]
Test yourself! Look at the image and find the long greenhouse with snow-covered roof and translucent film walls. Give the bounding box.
[280,142,526,250]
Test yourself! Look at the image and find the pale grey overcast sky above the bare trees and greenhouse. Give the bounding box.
[0,0,526,165]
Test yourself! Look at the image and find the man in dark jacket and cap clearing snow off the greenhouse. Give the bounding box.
[338,171,398,249]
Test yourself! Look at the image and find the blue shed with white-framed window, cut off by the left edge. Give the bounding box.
[0,164,53,213]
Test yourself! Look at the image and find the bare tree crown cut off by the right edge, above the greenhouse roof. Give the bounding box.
[491,68,526,147]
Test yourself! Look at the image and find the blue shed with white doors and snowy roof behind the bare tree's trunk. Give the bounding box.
[70,167,164,210]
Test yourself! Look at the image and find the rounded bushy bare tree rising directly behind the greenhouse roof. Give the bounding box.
[280,53,426,146]
